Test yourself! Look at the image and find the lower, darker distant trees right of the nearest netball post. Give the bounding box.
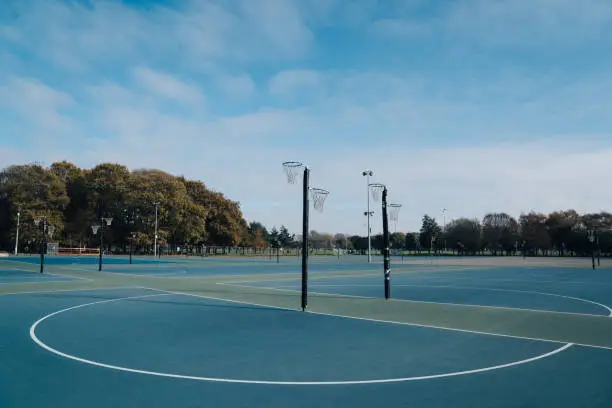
[318,210,612,256]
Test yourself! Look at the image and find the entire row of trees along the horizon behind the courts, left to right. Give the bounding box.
[0,161,612,255]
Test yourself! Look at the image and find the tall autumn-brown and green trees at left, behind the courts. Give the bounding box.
[0,161,294,251]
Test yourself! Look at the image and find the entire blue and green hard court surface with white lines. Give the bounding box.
[0,253,612,407]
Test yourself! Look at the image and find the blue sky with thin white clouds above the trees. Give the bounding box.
[0,0,612,235]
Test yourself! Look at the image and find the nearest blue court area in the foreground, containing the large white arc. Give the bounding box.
[0,288,612,408]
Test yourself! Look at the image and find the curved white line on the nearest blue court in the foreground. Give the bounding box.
[30,293,574,385]
